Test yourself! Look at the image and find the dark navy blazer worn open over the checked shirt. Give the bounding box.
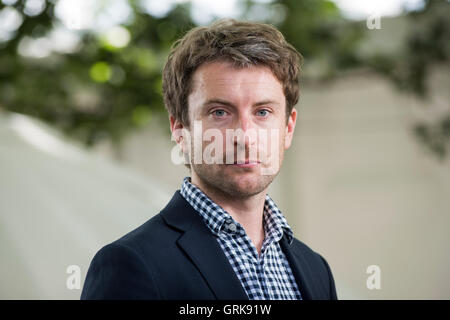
[81,190,337,300]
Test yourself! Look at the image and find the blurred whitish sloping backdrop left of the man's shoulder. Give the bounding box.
[0,112,172,299]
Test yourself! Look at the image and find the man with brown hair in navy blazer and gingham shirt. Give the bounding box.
[81,20,337,300]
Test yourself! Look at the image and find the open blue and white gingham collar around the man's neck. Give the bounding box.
[180,177,294,243]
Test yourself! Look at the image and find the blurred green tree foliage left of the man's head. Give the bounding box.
[0,1,194,145]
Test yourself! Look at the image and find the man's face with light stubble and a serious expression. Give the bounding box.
[171,62,297,197]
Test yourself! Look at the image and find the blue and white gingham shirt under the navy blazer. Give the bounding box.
[181,177,302,300]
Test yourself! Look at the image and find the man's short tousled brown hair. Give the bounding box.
[163,19,302,127]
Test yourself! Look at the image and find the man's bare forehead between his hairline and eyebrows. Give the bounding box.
[191,61,284,98]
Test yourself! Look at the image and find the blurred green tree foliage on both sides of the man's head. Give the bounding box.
[0,0,450,157]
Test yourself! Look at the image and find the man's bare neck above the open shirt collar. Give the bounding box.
[191,175,267,254]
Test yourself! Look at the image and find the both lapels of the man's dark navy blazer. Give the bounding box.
[161,190,314,300]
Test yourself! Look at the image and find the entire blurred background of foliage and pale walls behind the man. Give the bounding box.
[0,0,450,299]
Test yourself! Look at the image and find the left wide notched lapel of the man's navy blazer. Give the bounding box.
[161,191,248,300]
